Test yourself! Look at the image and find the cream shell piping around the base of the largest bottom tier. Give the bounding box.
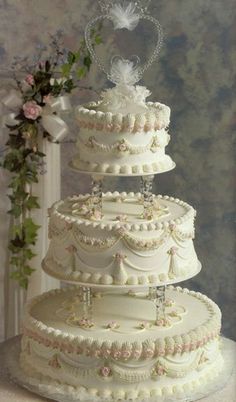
[20,348,224,401]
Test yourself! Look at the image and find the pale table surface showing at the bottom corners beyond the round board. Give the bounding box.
[0,338,236,402]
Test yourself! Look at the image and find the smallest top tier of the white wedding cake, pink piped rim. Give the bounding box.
[72,99,175,176]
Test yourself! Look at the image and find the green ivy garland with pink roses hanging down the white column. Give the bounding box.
[2,30,101,289]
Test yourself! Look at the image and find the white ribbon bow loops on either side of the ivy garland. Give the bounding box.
[0,89,71,142]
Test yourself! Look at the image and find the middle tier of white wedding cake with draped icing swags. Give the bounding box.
[43,192,201,287]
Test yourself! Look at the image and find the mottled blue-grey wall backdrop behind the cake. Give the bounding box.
[0,0,236,338]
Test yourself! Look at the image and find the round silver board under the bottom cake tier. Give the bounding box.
[6,337,235,402]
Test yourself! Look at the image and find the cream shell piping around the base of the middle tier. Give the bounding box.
[41,258,202,288]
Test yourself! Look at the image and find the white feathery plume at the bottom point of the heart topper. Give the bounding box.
[110,57,141,85]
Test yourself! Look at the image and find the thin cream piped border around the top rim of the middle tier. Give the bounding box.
[50,191,196,231]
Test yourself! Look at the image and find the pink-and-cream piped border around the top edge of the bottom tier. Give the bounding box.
[23,286,221,360]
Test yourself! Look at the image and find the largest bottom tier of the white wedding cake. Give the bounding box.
[20,287,223,401]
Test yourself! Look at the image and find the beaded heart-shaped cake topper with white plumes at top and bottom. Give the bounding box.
[85,0,163,85]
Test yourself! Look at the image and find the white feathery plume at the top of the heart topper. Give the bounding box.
[109,3,140,31]
